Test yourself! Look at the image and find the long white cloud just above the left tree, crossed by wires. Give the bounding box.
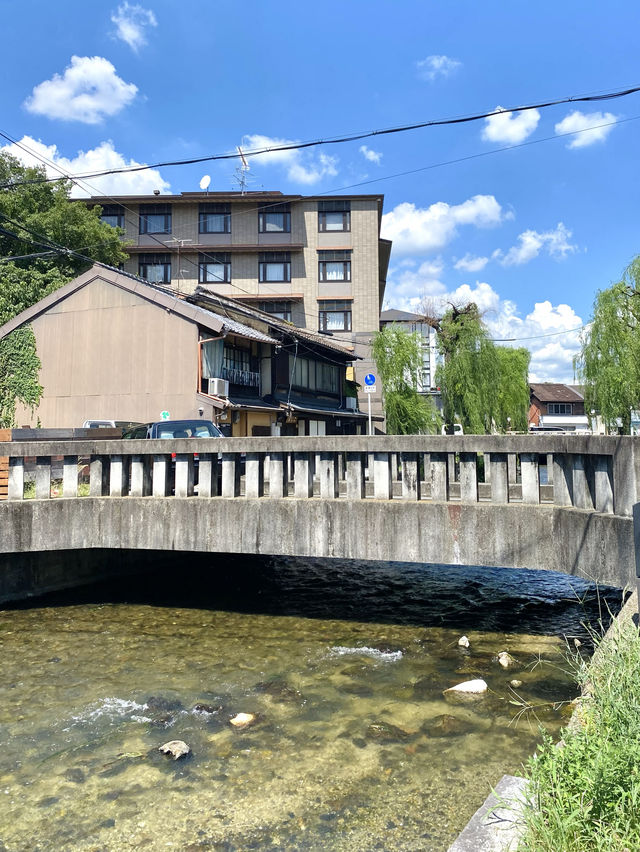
[0,136,170,198]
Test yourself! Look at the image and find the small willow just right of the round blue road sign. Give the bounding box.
[373,324,440,435]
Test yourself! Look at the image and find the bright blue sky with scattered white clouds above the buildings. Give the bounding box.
[0,0,640,381]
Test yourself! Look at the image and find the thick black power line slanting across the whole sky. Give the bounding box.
[0,86,640,189]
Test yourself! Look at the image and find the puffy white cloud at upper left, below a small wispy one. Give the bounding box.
[25,56,138,124]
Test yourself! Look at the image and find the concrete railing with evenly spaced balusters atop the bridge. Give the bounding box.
[0,435,638,516]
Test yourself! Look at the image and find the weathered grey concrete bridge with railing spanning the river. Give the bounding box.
[0,435,640,600]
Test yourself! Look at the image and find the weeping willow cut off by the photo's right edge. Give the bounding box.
[575,255,640,434]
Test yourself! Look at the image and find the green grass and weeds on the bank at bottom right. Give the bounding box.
[518,608,640,852]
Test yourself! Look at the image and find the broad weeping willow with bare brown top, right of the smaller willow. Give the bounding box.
[428,302,530,434]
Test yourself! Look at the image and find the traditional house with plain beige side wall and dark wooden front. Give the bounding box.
[0,265,366,436]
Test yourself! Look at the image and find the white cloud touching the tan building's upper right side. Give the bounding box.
[382,195,510,255]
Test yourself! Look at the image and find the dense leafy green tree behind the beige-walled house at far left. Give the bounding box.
[0,153,126,426]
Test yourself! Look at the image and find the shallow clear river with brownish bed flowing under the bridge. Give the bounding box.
[0,555,619,852]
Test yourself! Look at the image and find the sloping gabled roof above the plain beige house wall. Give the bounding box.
[0,264,279,344]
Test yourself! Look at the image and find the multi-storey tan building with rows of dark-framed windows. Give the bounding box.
[88,192,391,410]
